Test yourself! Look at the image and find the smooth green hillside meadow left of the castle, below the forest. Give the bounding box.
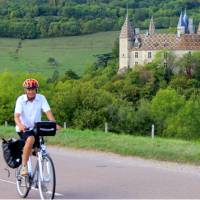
[0,31,118,76]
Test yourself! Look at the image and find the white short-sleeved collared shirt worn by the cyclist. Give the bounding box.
[15,94,50,132]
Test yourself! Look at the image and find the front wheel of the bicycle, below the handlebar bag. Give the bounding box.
[38,155,56,199]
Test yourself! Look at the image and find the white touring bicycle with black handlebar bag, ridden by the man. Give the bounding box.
[16,122,56,199]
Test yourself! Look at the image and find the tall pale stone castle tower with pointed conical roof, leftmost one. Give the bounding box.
[119,12,134,72]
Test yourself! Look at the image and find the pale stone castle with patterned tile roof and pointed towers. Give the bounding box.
[118,10,200,73]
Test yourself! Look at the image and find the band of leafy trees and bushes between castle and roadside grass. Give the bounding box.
[0,44,200,139]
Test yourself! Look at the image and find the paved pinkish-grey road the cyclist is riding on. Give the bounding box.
[0,147,200,199]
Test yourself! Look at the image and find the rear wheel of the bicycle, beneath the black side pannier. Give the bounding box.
[16,166,31,198]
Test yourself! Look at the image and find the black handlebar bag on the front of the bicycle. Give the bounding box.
[35,121,56,136]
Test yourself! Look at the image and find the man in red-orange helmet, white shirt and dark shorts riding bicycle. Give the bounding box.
[14,78,61,176]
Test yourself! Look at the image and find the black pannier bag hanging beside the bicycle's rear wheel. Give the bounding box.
[1,138,24,169]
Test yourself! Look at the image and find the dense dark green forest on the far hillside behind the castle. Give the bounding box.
[0,0,200,39]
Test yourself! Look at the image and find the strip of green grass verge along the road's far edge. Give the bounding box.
[0,127,200,164]
